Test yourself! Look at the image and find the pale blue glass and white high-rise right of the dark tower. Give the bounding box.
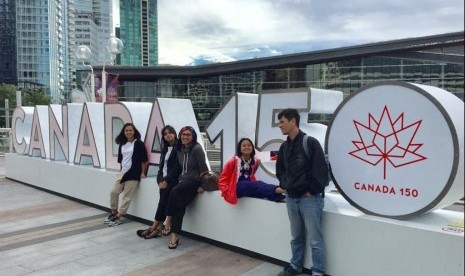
[14,0,70,103]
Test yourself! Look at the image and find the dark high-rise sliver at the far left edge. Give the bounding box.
[0,0,17,84]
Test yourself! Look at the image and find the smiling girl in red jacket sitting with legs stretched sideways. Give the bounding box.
[218,138,285,204]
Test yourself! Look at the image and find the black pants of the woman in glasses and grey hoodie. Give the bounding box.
[166,179,200,233]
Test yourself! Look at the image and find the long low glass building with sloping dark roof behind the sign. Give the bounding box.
[97,31,464,127]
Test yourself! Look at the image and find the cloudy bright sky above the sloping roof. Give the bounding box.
[113,0,464,65]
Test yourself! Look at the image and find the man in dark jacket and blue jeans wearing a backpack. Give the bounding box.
[276,108,328,276]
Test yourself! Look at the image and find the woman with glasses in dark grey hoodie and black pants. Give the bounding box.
[164,126,209,249]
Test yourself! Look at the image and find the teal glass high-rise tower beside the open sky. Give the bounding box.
[119,0,158,66]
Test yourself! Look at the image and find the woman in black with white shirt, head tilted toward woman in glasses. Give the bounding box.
[137,125,179,239]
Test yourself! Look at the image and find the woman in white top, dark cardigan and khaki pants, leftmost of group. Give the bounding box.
[104,123,148,226]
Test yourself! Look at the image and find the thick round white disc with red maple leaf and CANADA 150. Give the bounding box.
[326,82,464,218]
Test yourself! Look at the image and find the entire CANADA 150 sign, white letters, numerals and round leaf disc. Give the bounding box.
[12,82,463,218]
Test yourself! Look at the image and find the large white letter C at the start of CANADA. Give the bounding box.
[11,107,34,154]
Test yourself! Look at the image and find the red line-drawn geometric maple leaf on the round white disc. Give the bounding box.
[349,106,427,179]
